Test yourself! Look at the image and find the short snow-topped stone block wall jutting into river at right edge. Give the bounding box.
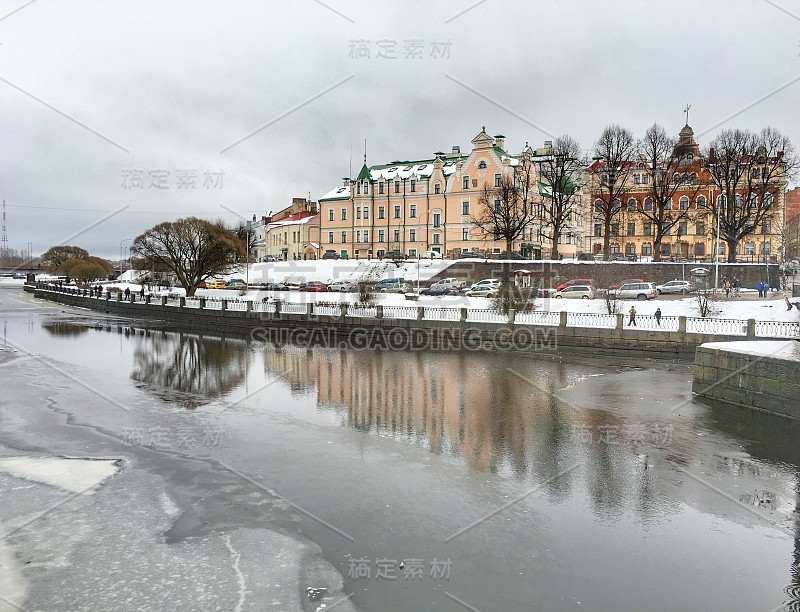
[692,341,800,420]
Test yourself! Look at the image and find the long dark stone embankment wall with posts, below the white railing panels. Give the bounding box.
[26,287,780,361]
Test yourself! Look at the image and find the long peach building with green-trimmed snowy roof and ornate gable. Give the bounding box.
[319,128,586,258]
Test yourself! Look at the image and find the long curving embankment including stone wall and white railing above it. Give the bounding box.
[26,285,800,360]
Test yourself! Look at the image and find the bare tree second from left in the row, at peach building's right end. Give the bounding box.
[539,134,583,259]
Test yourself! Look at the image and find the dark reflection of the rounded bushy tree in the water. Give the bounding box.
[131,331,248,408]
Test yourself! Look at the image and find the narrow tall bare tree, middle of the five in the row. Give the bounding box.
[589,124,636,261]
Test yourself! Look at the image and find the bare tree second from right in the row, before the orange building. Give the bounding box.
[637,123,700,261]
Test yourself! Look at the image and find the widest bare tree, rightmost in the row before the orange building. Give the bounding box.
[704,127,797,262]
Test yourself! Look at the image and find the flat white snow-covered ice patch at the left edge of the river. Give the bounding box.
[0,457,122,493]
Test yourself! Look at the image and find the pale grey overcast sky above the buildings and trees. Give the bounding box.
[0,0,800,259]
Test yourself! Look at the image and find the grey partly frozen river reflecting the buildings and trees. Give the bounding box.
[0,289,800,611]
